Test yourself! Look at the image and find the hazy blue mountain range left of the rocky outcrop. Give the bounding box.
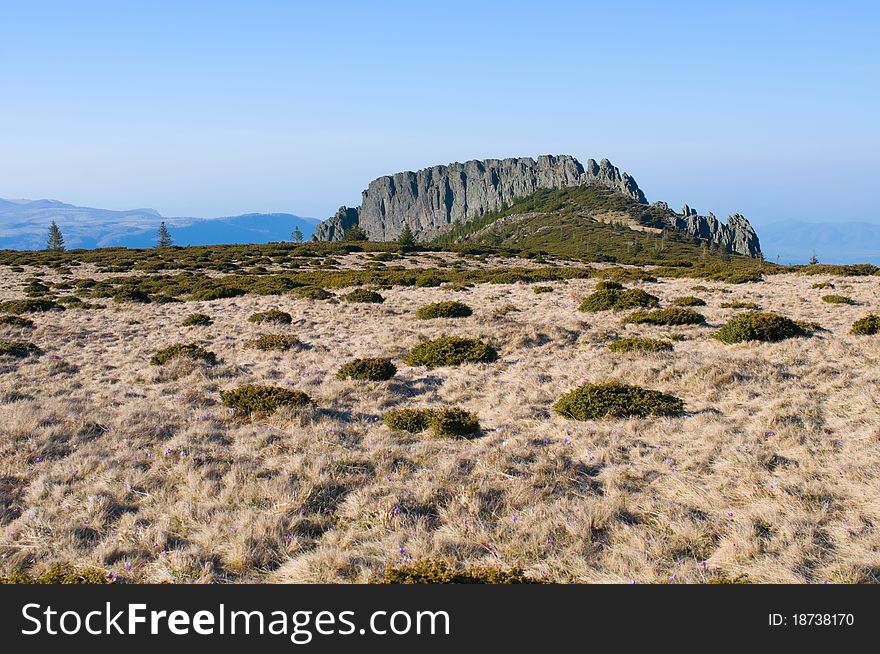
[0,199,318,250]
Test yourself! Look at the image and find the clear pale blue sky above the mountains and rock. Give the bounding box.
[0,0,880,225]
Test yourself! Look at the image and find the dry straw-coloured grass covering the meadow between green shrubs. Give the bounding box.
[0,264,880,583]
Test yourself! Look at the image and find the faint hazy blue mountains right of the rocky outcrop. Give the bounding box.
[758,221,880,265]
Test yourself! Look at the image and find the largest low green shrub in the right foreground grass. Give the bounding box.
[553,382,684,420]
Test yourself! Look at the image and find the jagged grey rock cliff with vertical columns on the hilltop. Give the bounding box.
[312,155,760,256]
